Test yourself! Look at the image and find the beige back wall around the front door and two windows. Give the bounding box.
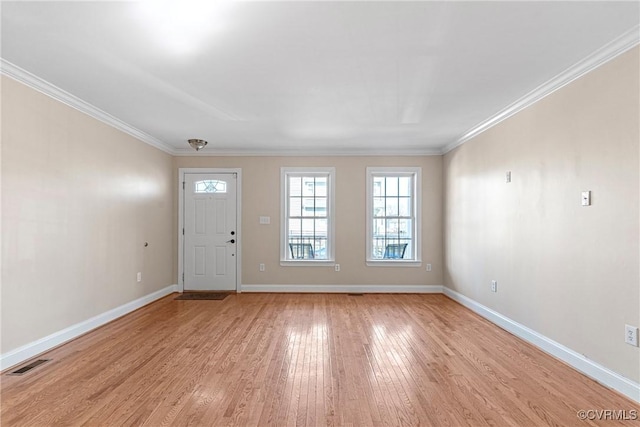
[174,156,442,285]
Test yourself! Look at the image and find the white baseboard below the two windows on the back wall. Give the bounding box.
[242,285,442,294]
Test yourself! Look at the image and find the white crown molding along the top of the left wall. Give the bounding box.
[0,58,174,154]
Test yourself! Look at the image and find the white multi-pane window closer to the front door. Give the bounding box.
[280,168,335,265]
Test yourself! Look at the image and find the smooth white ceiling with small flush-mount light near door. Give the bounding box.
[1,0,640,155]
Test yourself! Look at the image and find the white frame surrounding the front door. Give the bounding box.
[178,168,242,293]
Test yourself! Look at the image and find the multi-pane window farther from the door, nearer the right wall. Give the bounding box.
[367,167,421,265]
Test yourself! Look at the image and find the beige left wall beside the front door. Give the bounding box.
[0,77,175,354]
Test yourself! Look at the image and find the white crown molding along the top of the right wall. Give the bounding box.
[440,25,640,154]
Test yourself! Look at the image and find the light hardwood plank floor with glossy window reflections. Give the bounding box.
[1,294,640,427]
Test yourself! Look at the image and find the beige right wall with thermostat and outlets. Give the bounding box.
[444,48,640,382]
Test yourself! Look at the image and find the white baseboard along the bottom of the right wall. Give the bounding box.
[443,287,640,402]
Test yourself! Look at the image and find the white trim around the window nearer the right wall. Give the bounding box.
[366,166,422,267]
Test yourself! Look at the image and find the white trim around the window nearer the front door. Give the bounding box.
[280,167,336,267]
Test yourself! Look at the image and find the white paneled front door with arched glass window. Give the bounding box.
[183,173,238,291]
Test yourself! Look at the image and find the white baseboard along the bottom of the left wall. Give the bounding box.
[0,285,178,371]
